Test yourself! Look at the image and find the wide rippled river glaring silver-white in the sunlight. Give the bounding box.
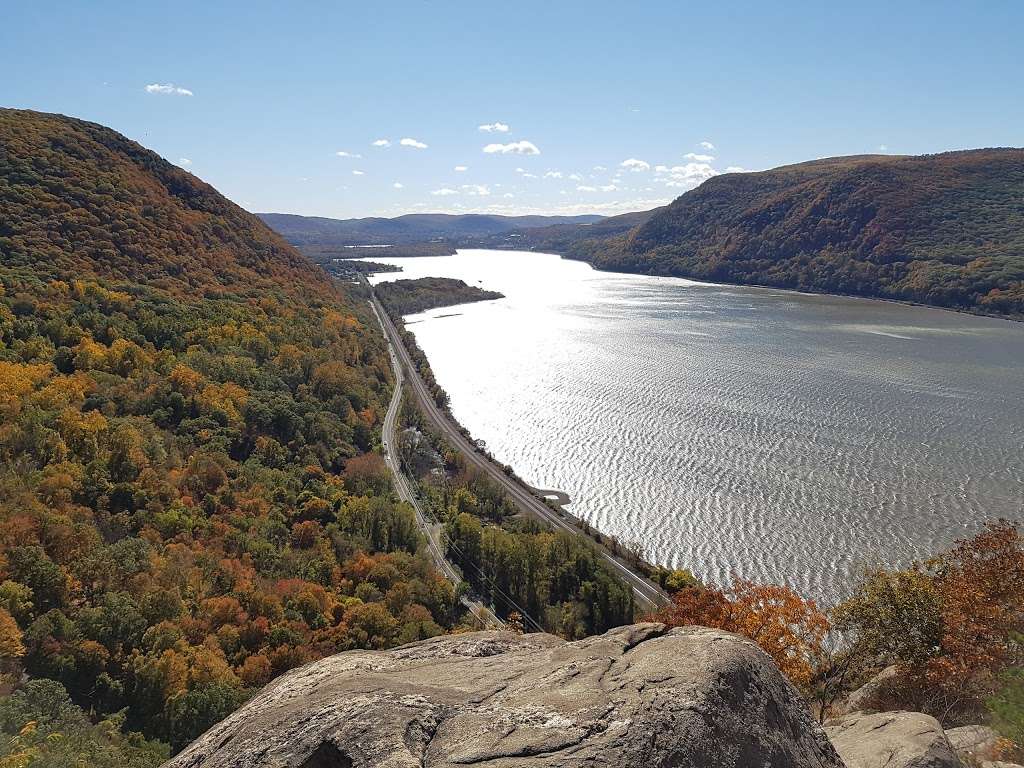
[374,251,1024,601]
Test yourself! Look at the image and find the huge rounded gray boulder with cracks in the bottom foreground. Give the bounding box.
[167,624,843,768]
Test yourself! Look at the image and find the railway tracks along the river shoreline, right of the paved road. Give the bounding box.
[367,294,669,609]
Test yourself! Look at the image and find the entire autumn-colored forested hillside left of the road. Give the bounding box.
[0,110,458,768]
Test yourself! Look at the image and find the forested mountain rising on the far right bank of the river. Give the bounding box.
[561,148,1024,317]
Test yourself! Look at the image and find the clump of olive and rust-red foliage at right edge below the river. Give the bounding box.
[836,520,1024,724]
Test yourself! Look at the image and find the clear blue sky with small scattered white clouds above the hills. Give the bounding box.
[0,0,1024,218]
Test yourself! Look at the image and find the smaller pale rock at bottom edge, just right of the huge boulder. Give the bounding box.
[825,712,961,768]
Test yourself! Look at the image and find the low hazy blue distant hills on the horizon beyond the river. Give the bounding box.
[257,213,601,246]
